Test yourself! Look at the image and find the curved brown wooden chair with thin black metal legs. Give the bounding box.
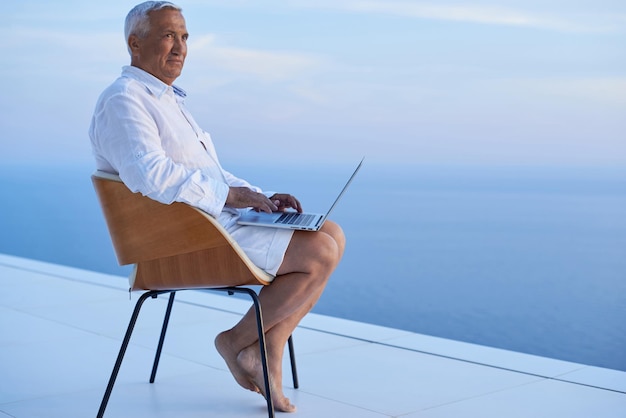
[91,171,298,418]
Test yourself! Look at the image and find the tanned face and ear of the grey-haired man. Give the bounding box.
[128,9,189,85]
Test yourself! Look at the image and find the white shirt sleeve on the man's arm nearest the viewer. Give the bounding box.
[92,89,229,217]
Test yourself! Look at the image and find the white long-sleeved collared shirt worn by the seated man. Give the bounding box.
[89,66,261,228]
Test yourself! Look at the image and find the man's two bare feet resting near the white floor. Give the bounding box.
[237,344,296,412]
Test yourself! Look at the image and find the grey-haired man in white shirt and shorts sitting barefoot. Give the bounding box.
[89,1,345,412]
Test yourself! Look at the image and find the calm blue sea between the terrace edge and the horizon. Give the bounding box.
[0,163,626,371]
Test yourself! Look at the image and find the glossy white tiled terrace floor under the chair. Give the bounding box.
[0,254,626,418]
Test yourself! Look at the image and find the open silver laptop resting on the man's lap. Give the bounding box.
[237,158,365,231]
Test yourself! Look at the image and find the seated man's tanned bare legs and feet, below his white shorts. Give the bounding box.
[215,222,345,412]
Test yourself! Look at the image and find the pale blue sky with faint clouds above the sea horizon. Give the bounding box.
[0,0,626,167]
